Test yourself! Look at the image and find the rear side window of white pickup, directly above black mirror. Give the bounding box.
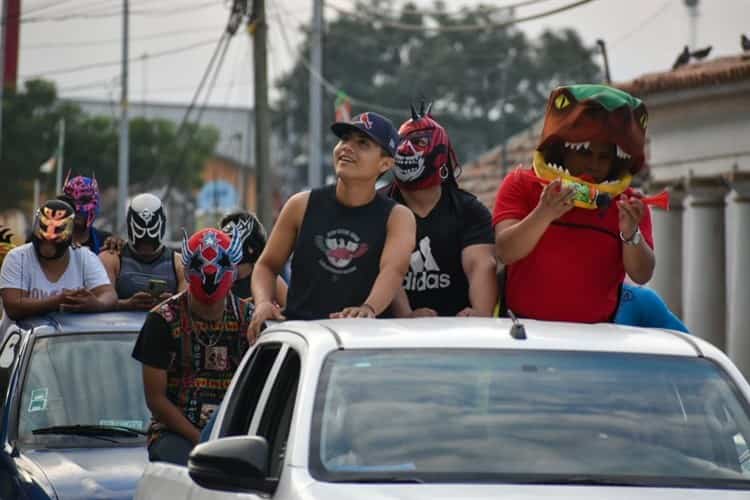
[219,343,281,437]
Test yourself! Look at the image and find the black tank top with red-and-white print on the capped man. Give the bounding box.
[285,185,395,319]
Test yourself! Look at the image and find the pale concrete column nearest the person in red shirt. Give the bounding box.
[649,183,685,318]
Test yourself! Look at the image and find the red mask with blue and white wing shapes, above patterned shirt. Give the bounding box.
[182,228,242,304]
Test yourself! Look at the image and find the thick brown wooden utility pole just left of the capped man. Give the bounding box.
[252,0,273,227]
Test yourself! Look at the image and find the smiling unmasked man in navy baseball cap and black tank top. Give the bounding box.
[248,112,416,341]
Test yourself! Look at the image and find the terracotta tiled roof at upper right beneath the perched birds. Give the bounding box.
[615,53,750,96]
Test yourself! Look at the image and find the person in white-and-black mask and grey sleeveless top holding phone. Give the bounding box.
[99,193,187,310]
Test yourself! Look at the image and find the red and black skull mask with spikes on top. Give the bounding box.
[393,103,457,190]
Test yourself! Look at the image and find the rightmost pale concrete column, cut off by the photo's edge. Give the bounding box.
[727,173,750,377]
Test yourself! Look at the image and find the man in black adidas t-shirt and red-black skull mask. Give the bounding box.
[381,103,497,317]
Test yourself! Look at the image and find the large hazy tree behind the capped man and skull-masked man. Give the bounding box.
[277,0,600,168]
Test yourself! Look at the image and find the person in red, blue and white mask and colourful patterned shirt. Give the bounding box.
[133,228,253,465]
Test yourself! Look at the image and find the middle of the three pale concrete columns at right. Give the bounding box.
[682,177,727,350]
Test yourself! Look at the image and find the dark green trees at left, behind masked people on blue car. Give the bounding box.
[0,80,219,210]
